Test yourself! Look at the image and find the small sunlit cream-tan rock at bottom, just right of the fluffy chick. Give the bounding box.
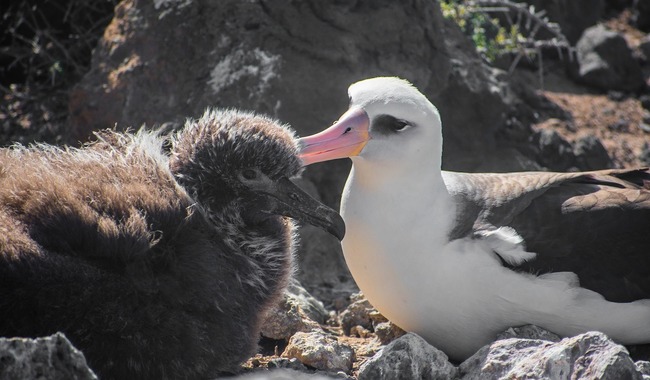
[282,331,354,373]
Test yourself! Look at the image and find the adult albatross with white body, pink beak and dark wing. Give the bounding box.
[301,77,650,359]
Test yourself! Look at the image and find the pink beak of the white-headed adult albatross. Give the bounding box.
[298,108,370,166]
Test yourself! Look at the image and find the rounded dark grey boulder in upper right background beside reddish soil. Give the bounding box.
[576,25,645,91]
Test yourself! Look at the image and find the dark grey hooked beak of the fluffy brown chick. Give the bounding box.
[247,178,345,240]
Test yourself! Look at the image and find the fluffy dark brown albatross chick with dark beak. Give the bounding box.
[0,110,344,379]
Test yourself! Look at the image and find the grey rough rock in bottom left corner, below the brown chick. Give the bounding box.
[0,333,97,380]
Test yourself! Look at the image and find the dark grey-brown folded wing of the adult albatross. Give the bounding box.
[444,169,650,302]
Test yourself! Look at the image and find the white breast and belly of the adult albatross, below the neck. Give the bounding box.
[341,172,650,360]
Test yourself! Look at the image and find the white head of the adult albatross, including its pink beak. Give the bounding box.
[300,77,442,172]
